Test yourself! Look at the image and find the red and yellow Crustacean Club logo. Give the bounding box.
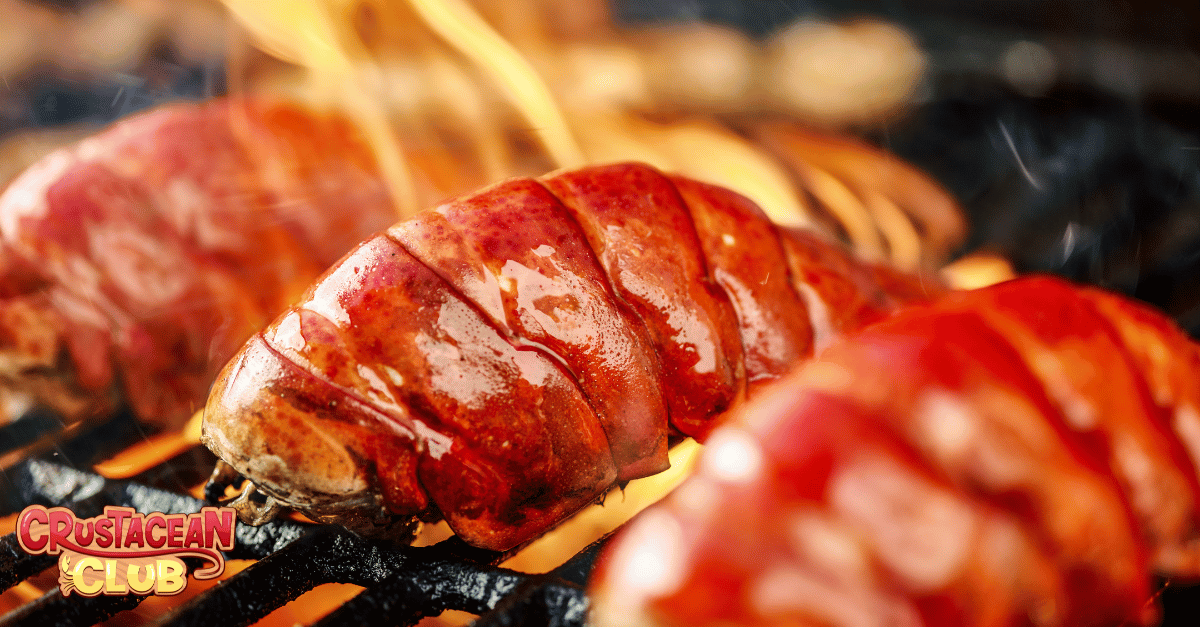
[17,506,238,597]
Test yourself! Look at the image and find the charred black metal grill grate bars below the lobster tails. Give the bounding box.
[0,416,604,627]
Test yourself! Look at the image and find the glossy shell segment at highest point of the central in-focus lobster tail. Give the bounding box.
[545,165,744,435]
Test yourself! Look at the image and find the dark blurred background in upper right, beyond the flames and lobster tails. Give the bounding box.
[617,0,1200,334]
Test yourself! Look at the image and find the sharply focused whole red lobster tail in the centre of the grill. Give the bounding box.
[203,163,941,550]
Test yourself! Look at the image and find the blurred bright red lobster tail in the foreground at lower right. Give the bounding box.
[593,276,1200,627]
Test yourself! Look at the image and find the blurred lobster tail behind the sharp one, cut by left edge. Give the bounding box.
[0,98,395,426]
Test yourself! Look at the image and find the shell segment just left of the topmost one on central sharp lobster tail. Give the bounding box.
[389,179,667,480]
